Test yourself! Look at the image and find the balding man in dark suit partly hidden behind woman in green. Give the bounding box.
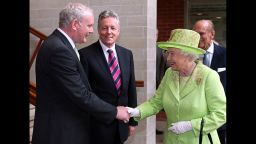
[193,20,226,144]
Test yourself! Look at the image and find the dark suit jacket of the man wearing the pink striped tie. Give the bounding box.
[79,41,137,144]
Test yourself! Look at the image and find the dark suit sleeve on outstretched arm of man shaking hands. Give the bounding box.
[50,48,117,123]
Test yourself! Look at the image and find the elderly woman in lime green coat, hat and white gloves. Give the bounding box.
[128,29,226,144]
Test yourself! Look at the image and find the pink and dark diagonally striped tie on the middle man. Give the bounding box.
[108,49,121,96]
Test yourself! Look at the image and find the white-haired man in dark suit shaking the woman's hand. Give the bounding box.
[32,3,130,144]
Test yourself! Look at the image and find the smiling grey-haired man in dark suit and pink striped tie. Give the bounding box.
[79,10,137,144]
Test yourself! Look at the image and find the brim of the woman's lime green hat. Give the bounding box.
[157,42,205,55]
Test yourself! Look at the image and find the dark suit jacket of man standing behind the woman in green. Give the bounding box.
[210,44,226,130]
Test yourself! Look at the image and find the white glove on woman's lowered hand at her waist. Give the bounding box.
[168,121,192,134]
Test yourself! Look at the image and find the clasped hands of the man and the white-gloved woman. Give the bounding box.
[116,106,140,123]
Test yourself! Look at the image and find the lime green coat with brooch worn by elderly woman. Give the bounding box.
[137,62,226,144]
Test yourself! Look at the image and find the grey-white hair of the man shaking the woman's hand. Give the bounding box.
[59,3,93,28]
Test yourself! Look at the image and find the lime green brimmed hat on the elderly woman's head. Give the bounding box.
[157,29,205,55]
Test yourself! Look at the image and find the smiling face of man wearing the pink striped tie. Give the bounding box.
[98,17,120,47]
